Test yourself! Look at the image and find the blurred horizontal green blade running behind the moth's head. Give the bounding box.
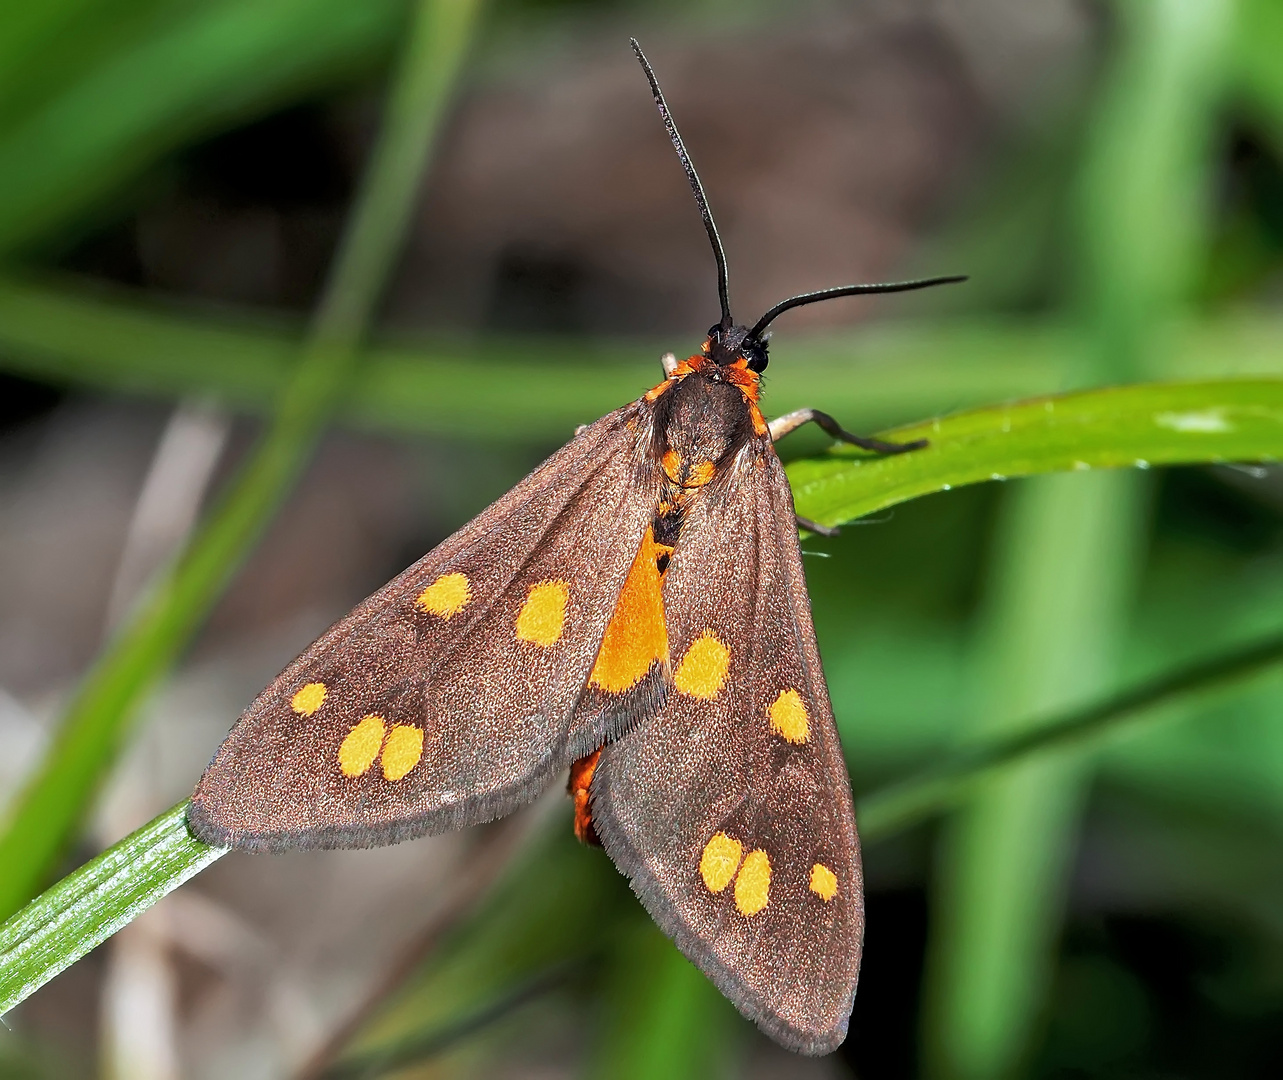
[0,278,1283,441]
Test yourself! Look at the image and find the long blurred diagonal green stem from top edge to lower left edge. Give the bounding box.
[0,0,479,912]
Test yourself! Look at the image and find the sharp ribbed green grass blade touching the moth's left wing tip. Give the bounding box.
[0,802,226,1015]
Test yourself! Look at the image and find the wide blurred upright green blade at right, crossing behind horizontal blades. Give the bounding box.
[922,0,1236,1080]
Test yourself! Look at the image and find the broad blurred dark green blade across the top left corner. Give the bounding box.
[0,0,405,253]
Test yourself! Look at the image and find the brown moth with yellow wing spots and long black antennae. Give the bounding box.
[187,41,961,1054]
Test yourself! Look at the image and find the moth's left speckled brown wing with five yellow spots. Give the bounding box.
[196,400,658,850]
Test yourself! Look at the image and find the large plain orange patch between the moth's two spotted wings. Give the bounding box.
[588,526,671,694]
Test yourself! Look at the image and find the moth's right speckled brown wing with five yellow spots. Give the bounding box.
[590,440,863,1054]
